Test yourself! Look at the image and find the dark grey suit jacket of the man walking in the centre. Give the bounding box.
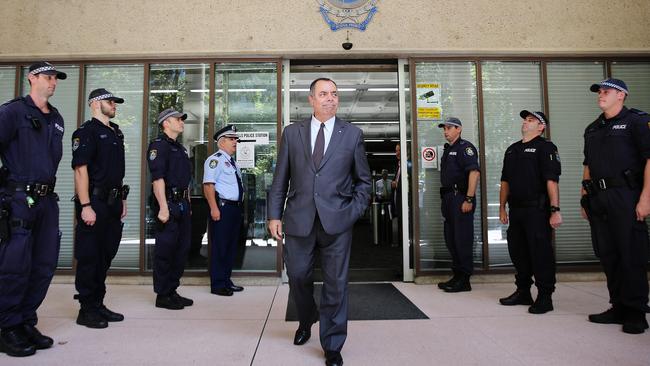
[267,117,371,237]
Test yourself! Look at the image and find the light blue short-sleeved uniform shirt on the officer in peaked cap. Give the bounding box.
[203,149,241,201]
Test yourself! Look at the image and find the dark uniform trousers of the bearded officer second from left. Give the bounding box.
[74,195,124,310]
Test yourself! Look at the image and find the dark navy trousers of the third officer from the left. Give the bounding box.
[153,199,192,295]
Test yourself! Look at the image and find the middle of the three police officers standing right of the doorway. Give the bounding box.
[499,110,562,314]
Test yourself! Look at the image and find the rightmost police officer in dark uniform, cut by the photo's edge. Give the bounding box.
[581,79,650,334]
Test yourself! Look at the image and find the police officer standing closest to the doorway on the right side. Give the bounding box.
[438,117,480,292]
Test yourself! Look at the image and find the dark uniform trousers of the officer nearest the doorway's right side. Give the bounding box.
[441,191,475,275]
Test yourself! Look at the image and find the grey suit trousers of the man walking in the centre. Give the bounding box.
[284,215,352,352]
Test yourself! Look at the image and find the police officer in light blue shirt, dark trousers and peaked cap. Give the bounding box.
[203,125,244,296]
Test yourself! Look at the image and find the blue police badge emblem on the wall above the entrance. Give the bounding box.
[316,0,378,31]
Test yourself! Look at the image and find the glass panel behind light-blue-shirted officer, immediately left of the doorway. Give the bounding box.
[214,62,278,272]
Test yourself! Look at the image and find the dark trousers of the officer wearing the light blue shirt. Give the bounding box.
[210,200,242,291]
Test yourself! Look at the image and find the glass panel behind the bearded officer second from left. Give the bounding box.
[84,65,144,270]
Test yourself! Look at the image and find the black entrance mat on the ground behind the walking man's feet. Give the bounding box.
[285,283,429,321]
